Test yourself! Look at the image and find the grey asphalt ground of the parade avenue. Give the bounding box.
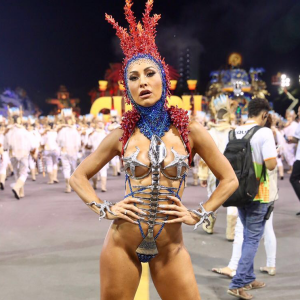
[0,172,300,300]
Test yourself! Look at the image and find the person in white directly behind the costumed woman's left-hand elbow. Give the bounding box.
[57,108,81,193]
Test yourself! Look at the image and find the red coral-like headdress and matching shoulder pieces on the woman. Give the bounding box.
[105,0,192,163]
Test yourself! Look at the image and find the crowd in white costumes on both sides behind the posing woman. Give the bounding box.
[0,105,300,199]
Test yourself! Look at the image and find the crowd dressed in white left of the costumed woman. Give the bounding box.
[0,108,120,200]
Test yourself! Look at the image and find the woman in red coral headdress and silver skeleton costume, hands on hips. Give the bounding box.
[70,0,238,300]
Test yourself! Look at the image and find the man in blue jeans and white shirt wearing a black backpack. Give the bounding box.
[229,98,277,299]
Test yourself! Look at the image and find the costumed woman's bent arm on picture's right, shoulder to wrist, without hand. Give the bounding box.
[189,122,238,211]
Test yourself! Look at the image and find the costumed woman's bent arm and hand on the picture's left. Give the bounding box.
[70,129,143,223]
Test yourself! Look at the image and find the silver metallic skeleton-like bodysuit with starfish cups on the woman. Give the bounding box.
[123,135,189,262]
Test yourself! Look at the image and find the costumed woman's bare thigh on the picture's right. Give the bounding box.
[149,245,201,300]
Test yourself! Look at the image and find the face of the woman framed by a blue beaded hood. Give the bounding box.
[127,59,162,107]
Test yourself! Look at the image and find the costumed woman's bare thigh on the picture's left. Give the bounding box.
[100,234,142,300]
